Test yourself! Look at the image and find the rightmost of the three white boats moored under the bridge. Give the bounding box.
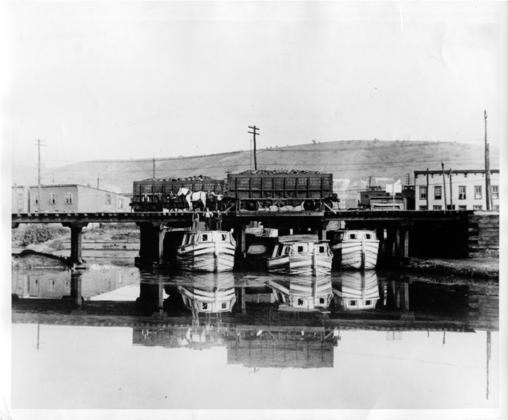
[332,230,379,270]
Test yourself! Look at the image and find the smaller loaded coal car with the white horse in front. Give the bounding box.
[131,176,224,211]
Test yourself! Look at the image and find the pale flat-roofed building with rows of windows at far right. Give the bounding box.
[415,169,499,211]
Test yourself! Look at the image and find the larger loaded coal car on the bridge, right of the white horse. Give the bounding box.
[224,170,338,211]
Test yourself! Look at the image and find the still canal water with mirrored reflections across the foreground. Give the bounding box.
[12,258,499,409]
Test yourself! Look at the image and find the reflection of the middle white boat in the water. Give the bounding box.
[266,277,333,312]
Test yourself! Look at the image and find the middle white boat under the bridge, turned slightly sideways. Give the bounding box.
[267,235,333,276]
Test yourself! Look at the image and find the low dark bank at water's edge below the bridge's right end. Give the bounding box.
[400,257,499,281]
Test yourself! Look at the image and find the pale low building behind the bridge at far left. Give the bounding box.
[23,184,130,213]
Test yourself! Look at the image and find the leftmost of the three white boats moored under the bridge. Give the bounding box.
[176,230,236,272]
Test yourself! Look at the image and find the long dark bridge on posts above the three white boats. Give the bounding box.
[12,210,499,266]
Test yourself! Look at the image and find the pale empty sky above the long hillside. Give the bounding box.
[2,1,506,169]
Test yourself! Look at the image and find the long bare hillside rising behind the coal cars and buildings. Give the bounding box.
[13,140,499,193]
